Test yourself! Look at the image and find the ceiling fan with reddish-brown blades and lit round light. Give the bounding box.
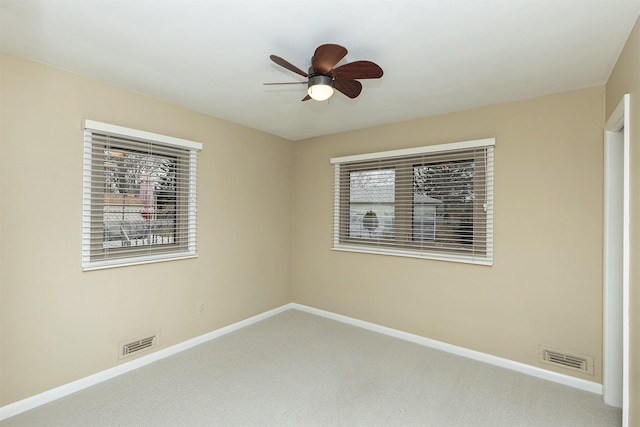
[265,44,383,101]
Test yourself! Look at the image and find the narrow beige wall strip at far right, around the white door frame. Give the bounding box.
[606,15,640,426]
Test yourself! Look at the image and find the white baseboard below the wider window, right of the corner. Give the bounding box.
[291,303,602,395]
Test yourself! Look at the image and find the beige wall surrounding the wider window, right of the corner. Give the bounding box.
[294,86,605,382]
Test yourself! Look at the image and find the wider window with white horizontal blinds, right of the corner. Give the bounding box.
[331,138,495,265]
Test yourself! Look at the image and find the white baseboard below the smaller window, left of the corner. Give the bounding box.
[0,304,292,421]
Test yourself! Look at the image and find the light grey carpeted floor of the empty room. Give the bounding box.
[0,310,621,427]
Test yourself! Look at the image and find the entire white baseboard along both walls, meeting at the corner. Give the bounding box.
[0,303,602,421]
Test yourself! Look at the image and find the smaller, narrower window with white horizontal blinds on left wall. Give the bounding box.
[82,120,202,270]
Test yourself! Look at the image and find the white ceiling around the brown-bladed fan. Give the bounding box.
[0,0,640,140]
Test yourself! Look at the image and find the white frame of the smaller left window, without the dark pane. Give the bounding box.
[82,120,202,271]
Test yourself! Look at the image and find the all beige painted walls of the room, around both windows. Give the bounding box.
[0,15,640,412]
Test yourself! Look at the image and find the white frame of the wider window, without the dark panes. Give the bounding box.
[330,138,495,265]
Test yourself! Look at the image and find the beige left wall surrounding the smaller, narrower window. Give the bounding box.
[0,54,293,406]
